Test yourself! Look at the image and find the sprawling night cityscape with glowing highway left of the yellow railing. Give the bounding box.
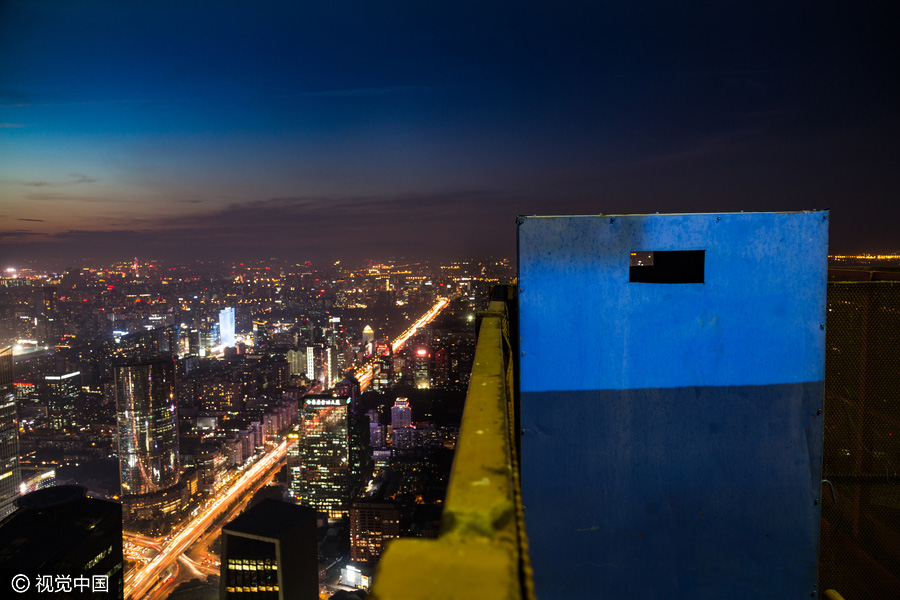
[0,258,513,598]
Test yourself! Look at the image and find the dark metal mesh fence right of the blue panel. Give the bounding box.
[819,281,900,600]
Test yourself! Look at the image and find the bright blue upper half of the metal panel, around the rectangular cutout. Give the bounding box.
[519,211,827,391]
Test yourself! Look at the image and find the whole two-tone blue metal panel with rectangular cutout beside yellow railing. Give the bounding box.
[519,211,827,600]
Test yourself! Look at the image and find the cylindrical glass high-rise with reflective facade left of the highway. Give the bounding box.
[116,359,179,517]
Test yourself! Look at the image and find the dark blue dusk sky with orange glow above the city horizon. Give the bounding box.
[0,0,900,267]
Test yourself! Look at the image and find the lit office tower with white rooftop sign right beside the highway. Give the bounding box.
[291,395,351,519]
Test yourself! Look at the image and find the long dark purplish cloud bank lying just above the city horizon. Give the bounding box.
[0,189,520,261]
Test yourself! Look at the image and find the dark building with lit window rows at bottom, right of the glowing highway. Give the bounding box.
[219,498,319,600]
